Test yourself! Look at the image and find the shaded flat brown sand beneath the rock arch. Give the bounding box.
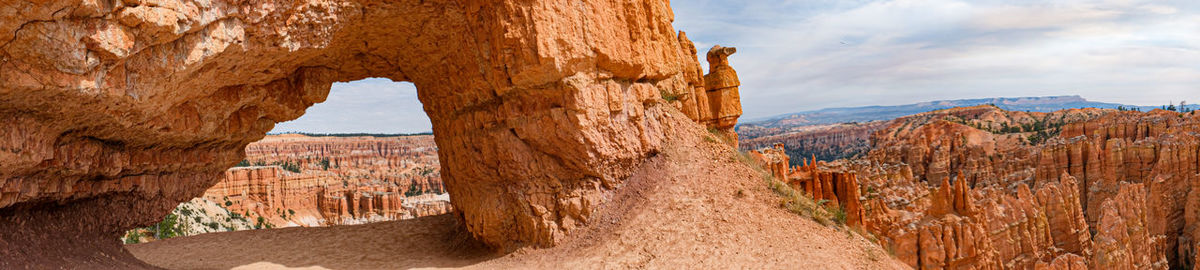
[125,214,503,269]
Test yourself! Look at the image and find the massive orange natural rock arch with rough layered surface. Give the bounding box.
[0,0,740,263]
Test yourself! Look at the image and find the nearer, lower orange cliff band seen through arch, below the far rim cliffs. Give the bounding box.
[204,166,451,227]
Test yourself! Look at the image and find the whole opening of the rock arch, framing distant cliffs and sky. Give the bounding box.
[121,78,452,245]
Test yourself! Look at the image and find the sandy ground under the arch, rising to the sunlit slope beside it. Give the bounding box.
[127,118,907,269]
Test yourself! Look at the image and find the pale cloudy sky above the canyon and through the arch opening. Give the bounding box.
[276,0,1200,132]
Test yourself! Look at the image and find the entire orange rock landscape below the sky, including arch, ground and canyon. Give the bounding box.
[7,0,1180,269]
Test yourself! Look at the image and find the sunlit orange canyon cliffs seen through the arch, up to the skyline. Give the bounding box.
[204,134,451,227]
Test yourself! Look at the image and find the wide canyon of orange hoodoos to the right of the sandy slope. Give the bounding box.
[754,106,1200,269]
